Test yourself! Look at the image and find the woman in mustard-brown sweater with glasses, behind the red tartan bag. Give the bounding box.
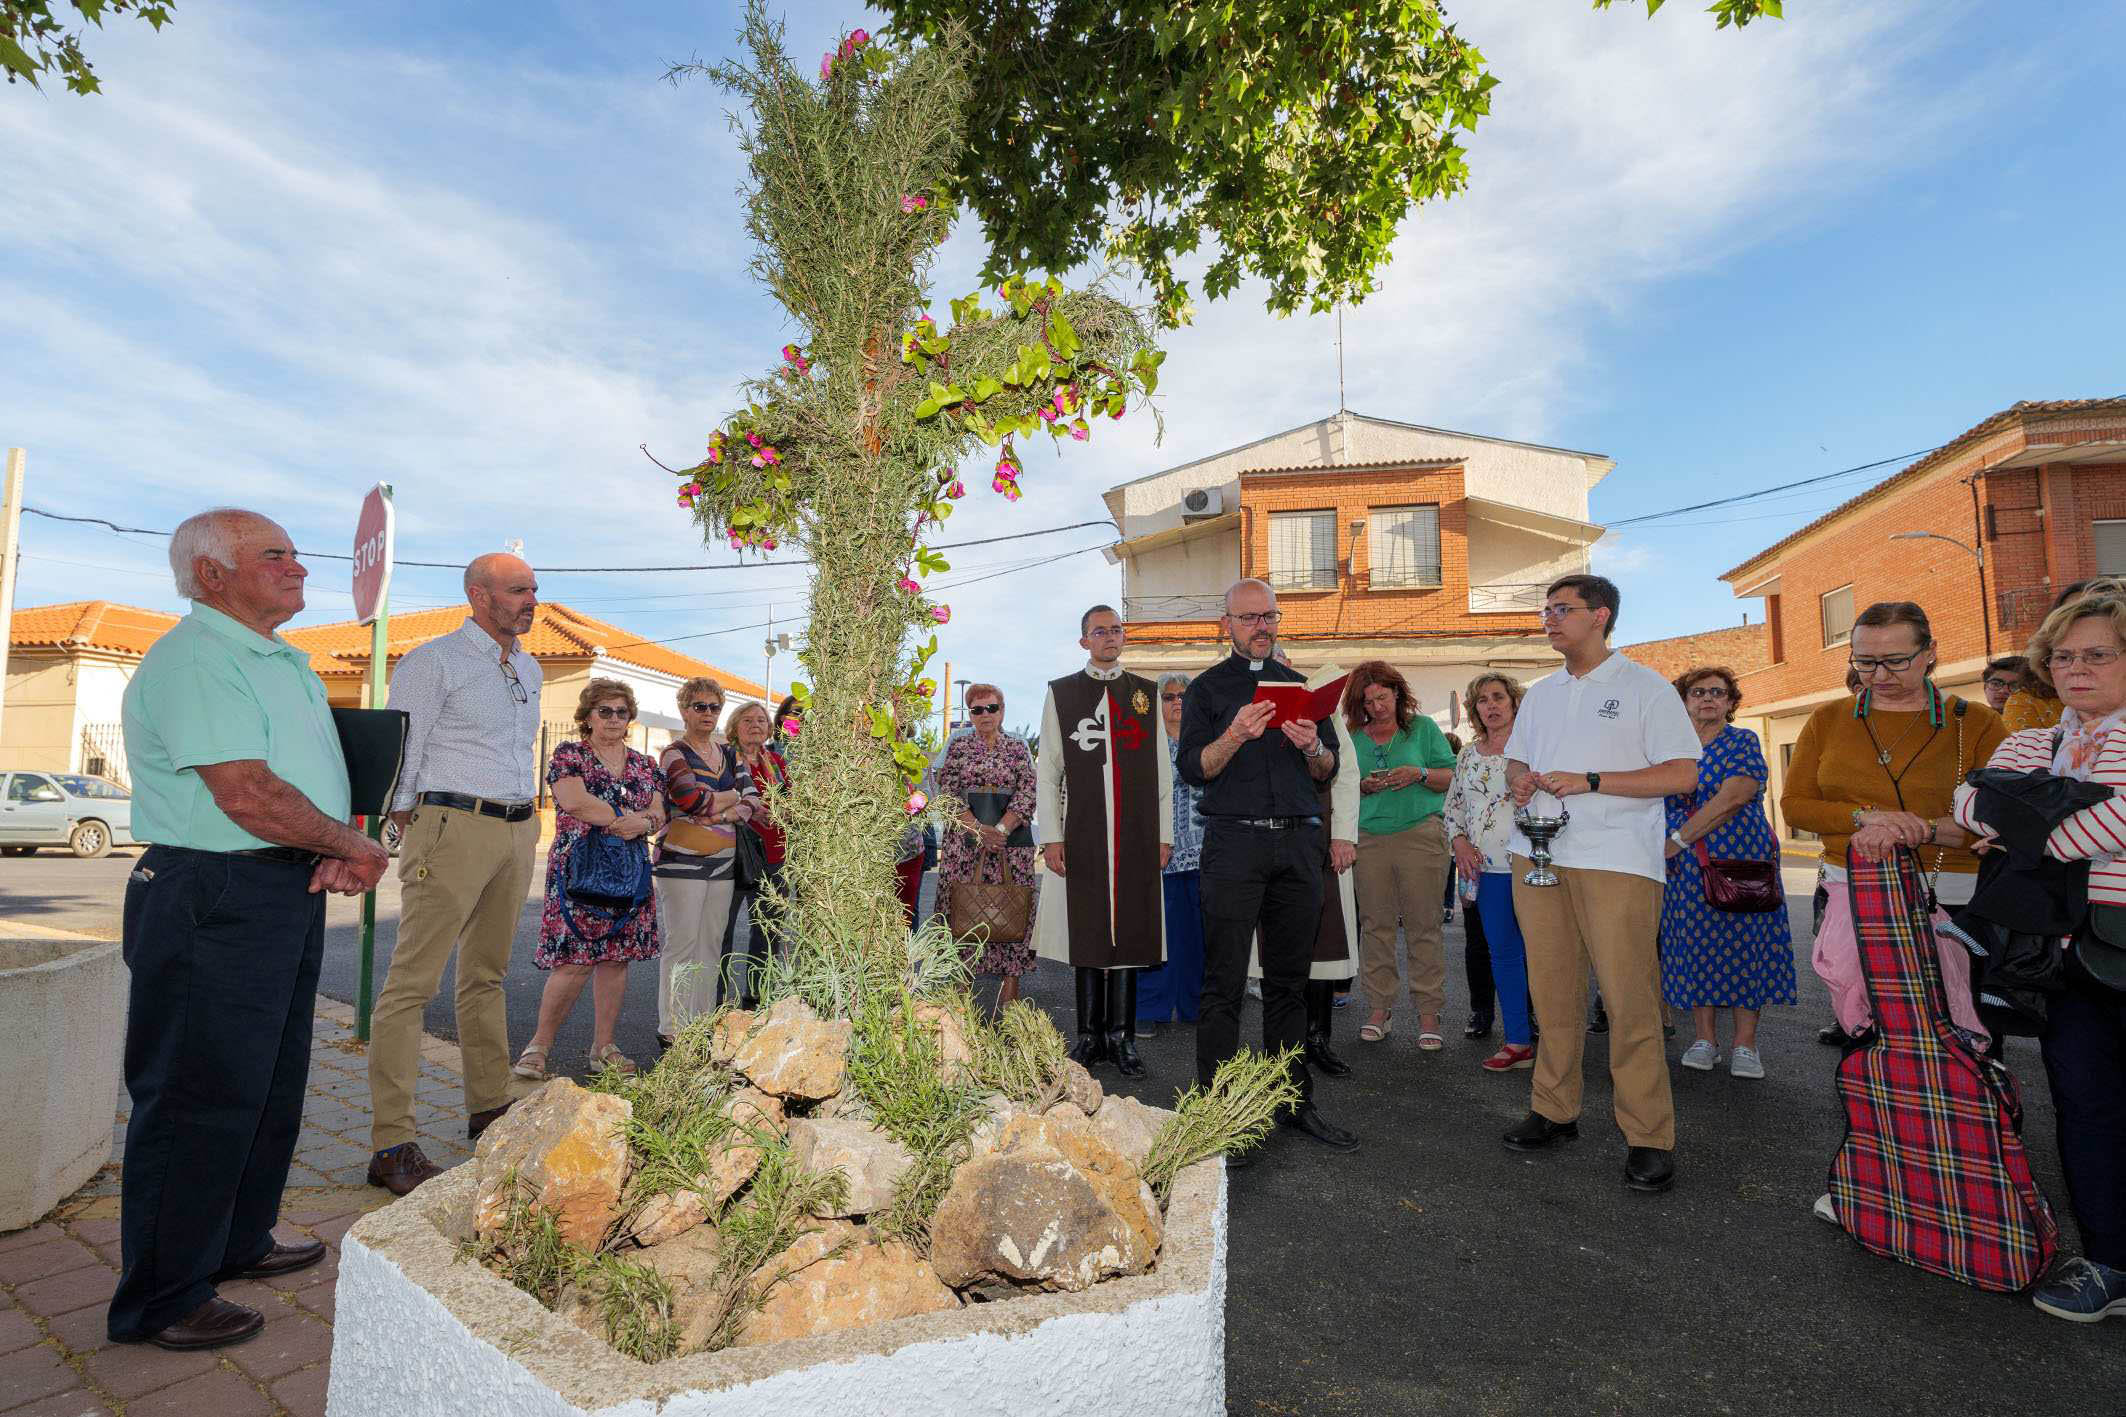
[1779,601,2007,1037]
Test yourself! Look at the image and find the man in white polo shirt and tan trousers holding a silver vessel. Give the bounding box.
[1505,576,1701,1192]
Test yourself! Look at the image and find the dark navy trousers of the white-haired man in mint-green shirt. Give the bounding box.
[106,846,325,1341]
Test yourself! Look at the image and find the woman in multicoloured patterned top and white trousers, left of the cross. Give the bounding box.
[653,678,759,1047]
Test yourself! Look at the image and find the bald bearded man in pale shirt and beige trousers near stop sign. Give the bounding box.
[370,552,542,1196]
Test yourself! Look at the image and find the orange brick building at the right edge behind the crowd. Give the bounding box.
[1722,399,2126,841]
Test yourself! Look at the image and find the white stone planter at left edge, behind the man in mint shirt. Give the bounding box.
[0,939,125,1230]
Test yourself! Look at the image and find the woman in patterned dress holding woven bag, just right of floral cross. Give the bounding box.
[935,684,1040,1009]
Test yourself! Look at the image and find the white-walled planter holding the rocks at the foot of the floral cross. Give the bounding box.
[325,1160,1225,1417]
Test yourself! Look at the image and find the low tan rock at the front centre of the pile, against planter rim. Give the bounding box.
[738,1226,959,1347]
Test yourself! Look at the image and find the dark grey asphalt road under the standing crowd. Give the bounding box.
[0,856,2126,1417]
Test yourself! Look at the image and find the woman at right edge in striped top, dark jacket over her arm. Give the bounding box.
[1956,593,2126,1324]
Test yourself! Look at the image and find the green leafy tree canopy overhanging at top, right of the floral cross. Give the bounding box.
[880,0,1779,323]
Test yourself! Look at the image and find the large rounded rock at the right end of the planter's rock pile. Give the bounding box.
[931,1115,1165,1296]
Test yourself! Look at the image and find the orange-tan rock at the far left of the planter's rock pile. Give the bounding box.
[472,1077,634,1249]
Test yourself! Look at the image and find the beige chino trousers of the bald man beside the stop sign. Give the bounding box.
[370,805,538,1151]
